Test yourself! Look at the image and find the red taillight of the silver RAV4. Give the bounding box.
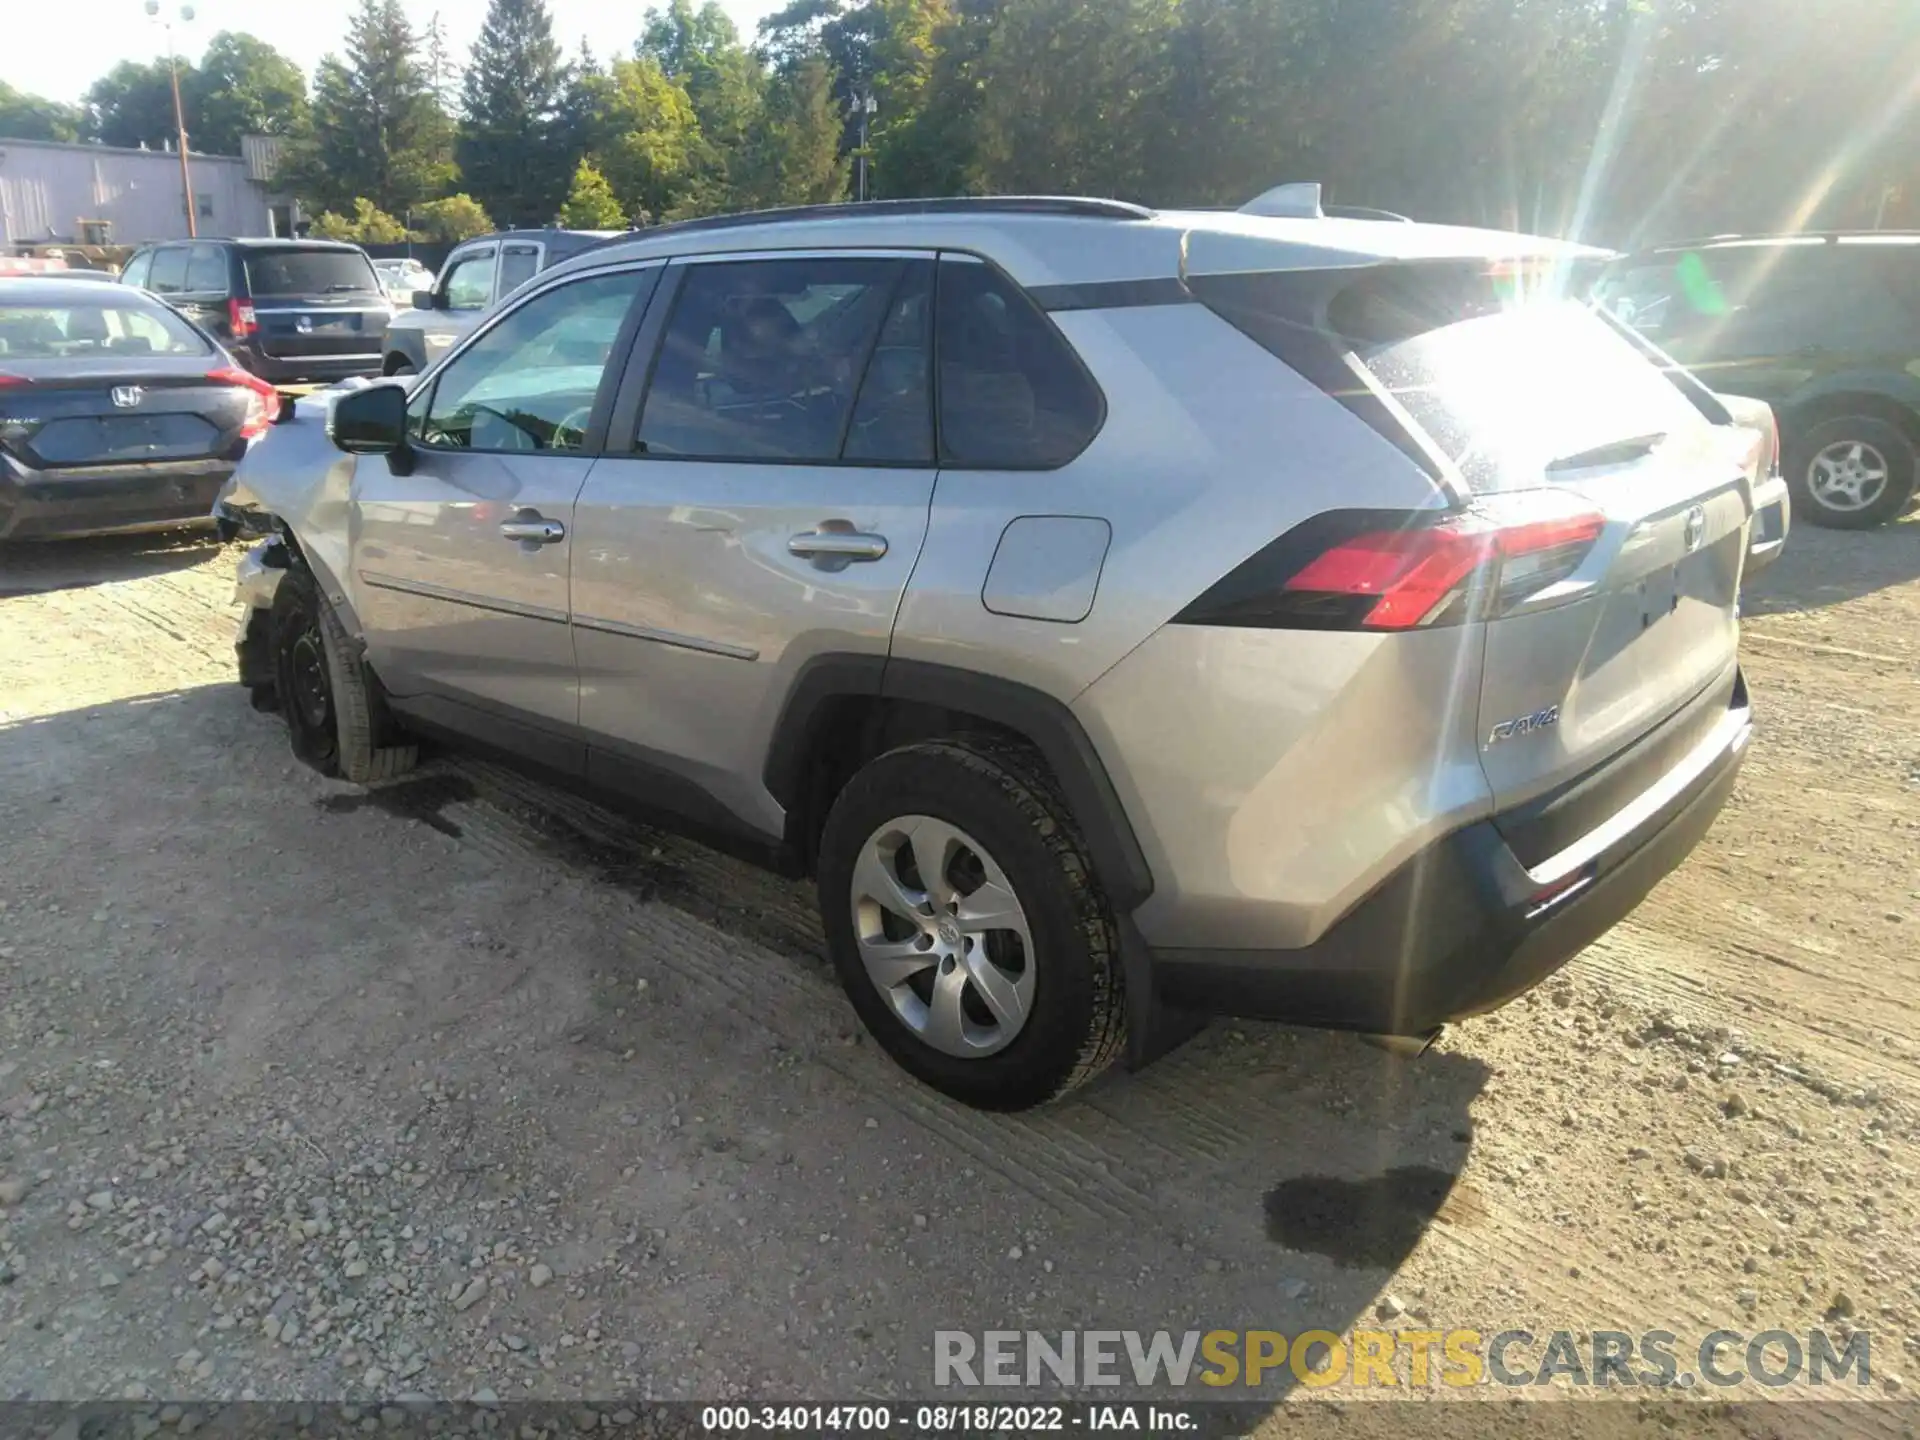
[1175,492,1607,630]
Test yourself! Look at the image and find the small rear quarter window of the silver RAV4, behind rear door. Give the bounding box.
[937,257,1106,470]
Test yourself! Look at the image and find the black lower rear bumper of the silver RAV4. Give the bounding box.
[1154,682,1753,1035]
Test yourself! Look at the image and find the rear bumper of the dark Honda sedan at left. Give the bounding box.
[0,461,234,540]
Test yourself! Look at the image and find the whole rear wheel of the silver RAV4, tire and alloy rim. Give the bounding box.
[818,735,1127,1110]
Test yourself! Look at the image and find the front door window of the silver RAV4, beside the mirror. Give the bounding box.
[409,269,659,451]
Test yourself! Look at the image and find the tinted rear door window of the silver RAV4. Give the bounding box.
[639,255,906,463]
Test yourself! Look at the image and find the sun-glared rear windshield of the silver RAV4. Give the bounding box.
[1194,263,1705,492]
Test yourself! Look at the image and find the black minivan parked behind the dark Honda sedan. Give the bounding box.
[121,240,394,384]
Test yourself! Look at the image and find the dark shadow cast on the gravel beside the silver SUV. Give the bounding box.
[0,685,1501,1404]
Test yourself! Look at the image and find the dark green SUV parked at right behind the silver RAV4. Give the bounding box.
[1596,232,1920,530]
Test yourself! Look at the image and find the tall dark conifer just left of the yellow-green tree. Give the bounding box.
[455,0,566,225]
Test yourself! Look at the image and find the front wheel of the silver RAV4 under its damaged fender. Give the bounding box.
[269,561,419,785]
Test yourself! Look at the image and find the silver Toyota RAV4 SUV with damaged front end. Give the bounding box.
[221,198,1763,1108]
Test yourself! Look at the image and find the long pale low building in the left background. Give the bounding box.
[0,136,298,246]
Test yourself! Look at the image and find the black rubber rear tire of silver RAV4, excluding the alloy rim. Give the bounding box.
[818,735,1127,1110]
